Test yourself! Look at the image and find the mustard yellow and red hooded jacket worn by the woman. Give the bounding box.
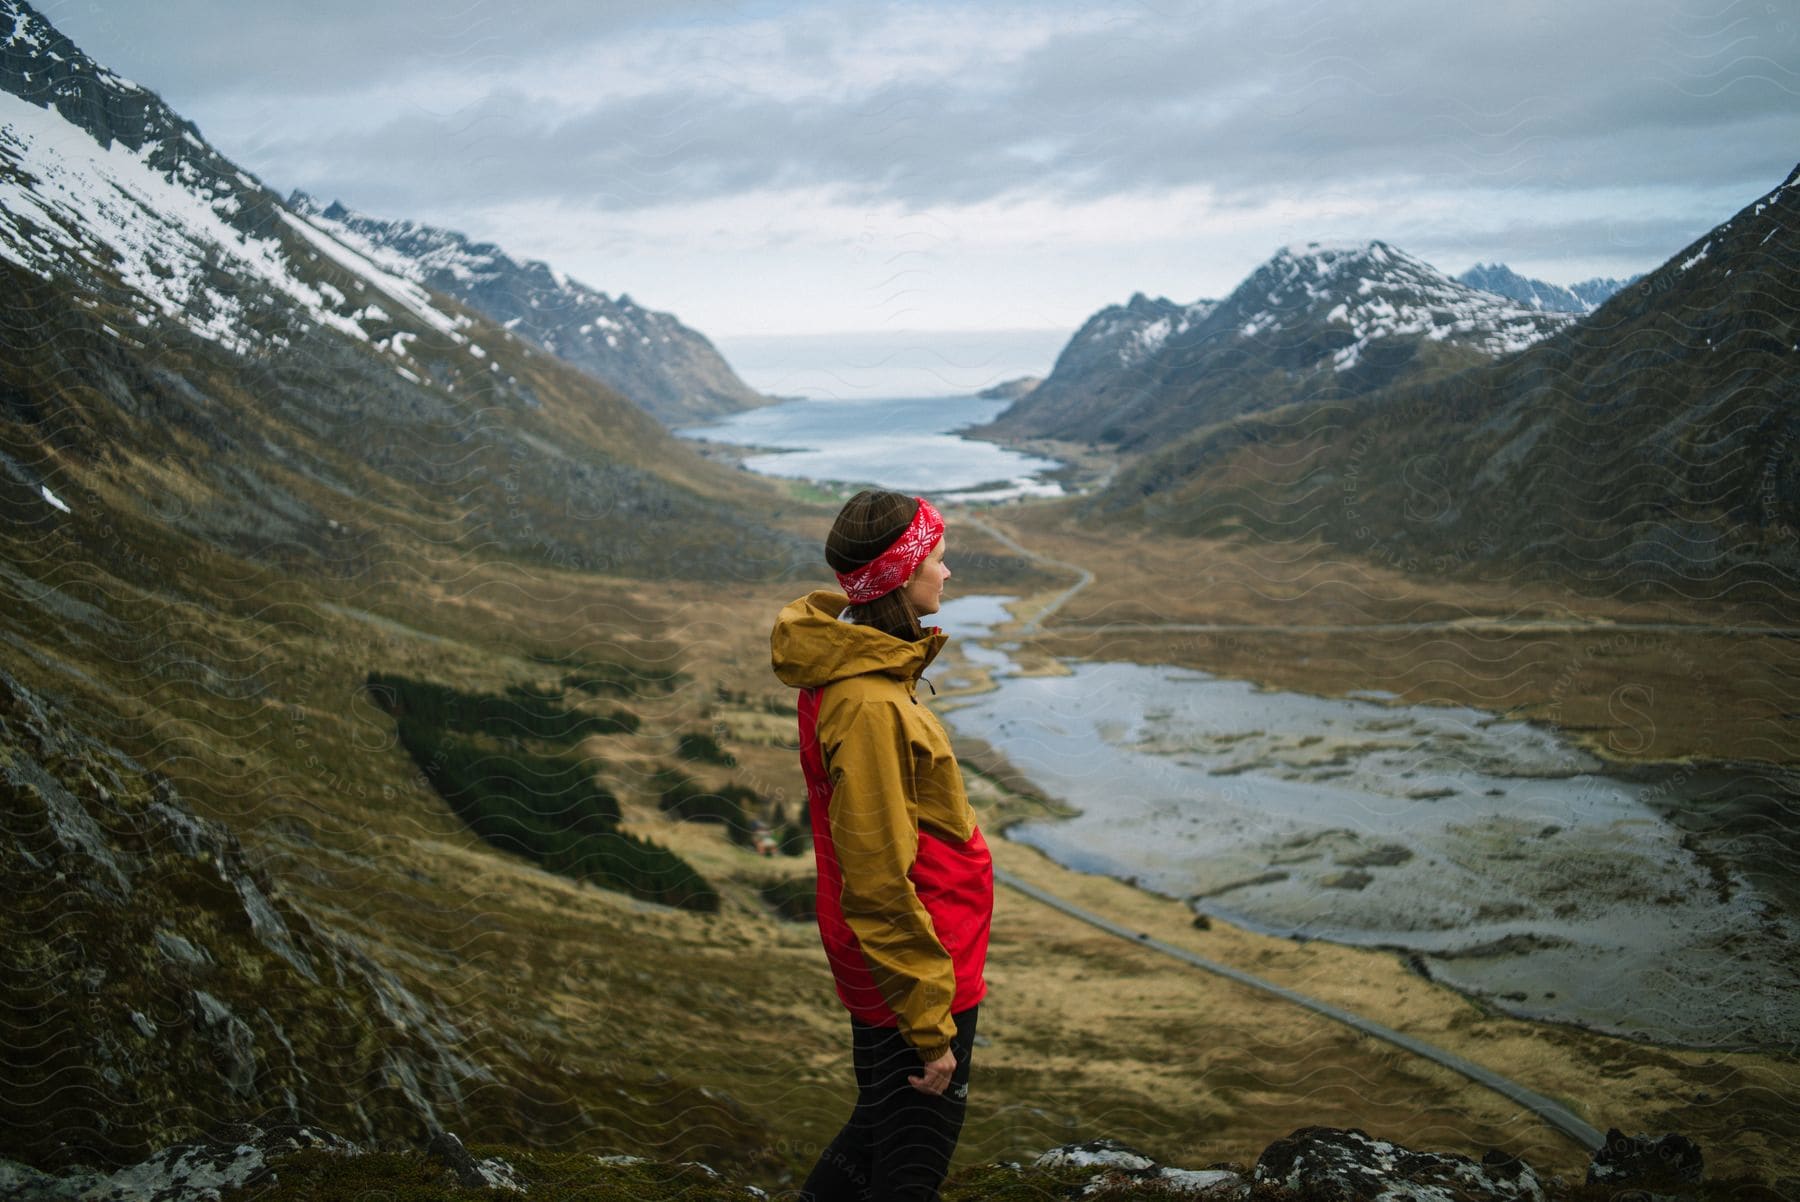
[770,592,994,1062]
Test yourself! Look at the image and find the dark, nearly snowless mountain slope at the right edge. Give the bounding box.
[1093,162,1800,605]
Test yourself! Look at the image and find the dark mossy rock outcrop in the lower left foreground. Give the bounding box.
[0,671,495,1168]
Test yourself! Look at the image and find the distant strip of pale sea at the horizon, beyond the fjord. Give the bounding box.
[711,329,1075,401]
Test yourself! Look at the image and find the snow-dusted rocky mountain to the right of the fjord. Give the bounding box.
[985,241,1568,450]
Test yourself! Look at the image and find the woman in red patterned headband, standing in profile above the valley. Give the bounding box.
[770,491,994,1202]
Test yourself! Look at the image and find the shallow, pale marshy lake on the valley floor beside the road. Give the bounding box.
[940,597,1800,1049]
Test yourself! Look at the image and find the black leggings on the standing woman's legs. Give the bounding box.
[799,1006,981,1202]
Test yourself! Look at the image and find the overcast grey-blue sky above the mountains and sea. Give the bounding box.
[28,0,1800,390]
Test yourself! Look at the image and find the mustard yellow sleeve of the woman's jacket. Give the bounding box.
[819,698,956,1063]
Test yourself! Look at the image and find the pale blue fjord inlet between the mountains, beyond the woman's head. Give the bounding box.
[679,396,1062,502]
